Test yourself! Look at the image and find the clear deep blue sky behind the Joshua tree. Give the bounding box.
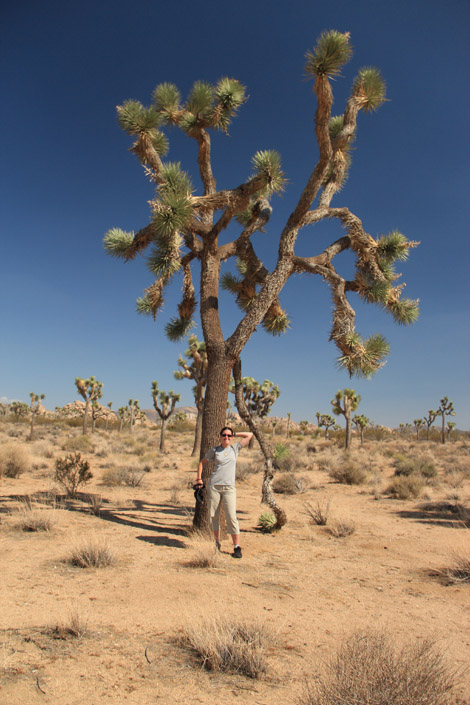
[0,0,470,429]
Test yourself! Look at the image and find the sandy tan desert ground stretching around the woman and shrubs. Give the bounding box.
[0,422,470,705]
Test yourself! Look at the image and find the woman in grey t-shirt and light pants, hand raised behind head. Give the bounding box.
[196,426,253,558]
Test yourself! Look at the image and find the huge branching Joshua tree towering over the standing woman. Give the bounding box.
[104,31,418,526]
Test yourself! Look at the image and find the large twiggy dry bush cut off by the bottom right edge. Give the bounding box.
[298,632,457,705]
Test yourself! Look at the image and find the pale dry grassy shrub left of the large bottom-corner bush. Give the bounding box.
[181,616,275,678]
